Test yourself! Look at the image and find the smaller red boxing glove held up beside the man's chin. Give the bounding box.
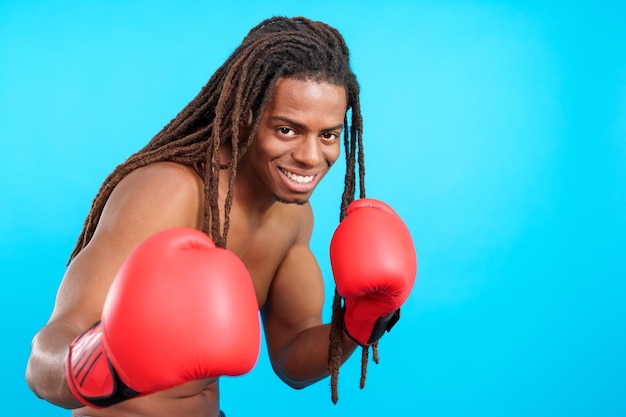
[330,198,417,346]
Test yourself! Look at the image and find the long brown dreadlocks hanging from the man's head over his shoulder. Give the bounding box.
[69,17,376,403]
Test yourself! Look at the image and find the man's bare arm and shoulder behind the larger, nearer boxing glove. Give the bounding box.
[26,164,200,408]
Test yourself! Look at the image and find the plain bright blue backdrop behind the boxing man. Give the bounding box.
[0,0,626,417]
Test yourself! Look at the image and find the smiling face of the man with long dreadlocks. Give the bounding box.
[246,78,347,204]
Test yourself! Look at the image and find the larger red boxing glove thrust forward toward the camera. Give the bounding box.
[65,228,260,407]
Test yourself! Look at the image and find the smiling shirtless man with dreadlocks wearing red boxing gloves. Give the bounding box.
[27,18,416,417]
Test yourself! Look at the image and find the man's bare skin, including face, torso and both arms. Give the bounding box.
[27,78,357,417]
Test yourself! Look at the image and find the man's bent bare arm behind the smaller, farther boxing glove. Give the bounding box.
[262,209,358,389]
